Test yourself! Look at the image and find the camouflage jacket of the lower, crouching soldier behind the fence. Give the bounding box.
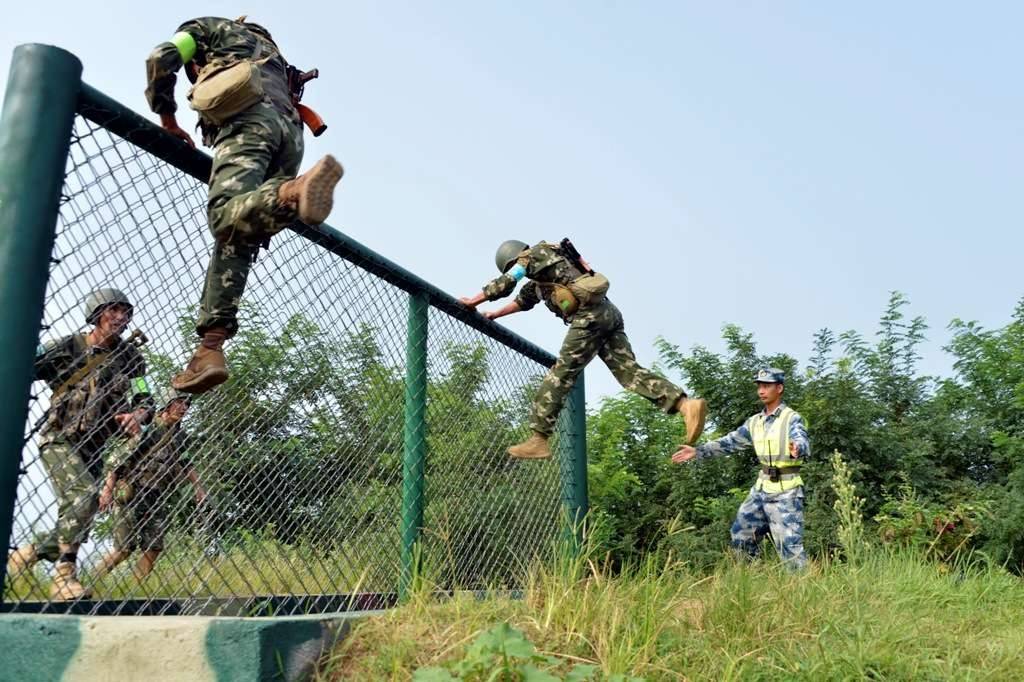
[108,420,191,495]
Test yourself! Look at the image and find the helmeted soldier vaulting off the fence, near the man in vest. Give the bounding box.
[460,240,707,459]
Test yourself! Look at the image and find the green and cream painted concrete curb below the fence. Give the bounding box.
[0,613,367,682]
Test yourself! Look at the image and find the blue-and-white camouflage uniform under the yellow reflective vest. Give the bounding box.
[696,404,811,569]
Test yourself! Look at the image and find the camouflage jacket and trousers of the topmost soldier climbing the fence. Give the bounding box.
[145,16,303,337]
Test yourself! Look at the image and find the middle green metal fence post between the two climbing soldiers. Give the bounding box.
[398,292,430,599]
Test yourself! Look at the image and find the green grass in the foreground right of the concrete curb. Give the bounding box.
[318,550,1024,681]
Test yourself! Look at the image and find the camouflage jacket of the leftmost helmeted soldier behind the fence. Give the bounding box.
[35,334,152,442]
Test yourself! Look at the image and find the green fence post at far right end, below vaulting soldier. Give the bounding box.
[560,372,590,550]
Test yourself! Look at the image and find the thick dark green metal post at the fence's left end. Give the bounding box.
[0,45,82,601]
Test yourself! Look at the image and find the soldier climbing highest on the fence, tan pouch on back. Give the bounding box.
[145,16,342,393]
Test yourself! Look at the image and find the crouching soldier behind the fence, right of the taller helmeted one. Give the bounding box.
[94,391,206,581]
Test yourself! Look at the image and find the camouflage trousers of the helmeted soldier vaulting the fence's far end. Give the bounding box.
[529,300,684,435]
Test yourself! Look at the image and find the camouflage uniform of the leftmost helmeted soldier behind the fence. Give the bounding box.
[35,334,151,561]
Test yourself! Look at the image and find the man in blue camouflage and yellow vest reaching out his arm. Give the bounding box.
[672,368,811,569]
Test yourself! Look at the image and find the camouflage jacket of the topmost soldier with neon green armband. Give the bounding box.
[145,16,298,123]
